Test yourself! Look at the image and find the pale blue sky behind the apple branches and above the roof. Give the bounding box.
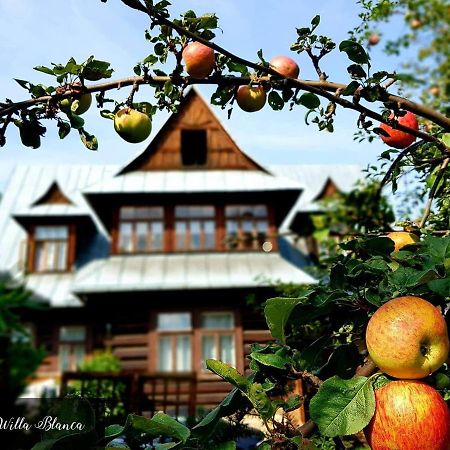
[0,0,414,192]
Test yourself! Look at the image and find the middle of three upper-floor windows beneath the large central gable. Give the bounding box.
[175,206,216,251]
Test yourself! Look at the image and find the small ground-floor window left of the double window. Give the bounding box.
[58,326,86,372]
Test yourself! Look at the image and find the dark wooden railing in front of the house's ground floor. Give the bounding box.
[60,372,197,418]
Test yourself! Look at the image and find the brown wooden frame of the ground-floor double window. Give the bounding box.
[148,308,244,380]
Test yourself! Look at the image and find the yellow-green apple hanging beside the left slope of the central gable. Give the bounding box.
[114,108,152,144]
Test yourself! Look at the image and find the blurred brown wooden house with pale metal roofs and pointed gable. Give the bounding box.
[0,89,360,414]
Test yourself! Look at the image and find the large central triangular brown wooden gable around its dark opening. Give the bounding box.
[118,88,268,175]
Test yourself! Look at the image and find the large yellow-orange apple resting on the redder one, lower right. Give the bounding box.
[366,296,449,379]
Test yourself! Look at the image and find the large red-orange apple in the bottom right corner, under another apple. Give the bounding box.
[364,380,450,450]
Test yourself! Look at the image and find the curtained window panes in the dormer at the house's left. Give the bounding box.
[32,226,69,272]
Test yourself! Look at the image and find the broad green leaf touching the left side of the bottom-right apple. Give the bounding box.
[310,376,375,437]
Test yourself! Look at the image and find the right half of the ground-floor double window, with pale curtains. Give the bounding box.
[200,312,236,371]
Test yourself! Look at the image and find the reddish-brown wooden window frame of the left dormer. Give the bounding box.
[27,224,76,274]
